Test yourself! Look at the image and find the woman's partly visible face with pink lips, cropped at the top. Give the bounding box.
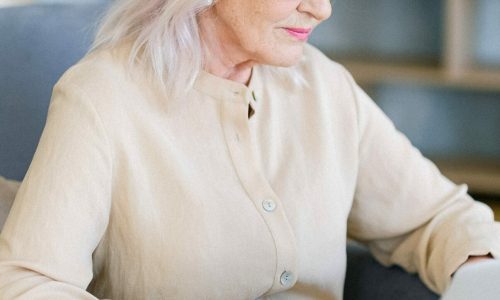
[205,0,331,66]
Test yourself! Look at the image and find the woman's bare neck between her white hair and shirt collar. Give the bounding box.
[198,11,256,85]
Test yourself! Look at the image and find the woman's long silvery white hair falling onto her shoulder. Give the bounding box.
[90,0,305,98]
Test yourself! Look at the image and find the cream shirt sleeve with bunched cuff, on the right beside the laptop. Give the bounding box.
[348,74,500,293]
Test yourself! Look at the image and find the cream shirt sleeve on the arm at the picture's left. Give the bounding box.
[0,78,112,300]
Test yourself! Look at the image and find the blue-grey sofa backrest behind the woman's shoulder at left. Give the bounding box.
[0,0,109,180]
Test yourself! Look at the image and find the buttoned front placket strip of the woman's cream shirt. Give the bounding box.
[221,95,297,294]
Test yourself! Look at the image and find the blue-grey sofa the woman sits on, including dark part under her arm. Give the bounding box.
[0,1,438,300]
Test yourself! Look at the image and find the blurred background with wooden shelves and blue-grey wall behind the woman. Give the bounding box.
[0,0,500,217]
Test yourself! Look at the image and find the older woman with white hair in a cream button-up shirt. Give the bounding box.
[0,0,500,299]
